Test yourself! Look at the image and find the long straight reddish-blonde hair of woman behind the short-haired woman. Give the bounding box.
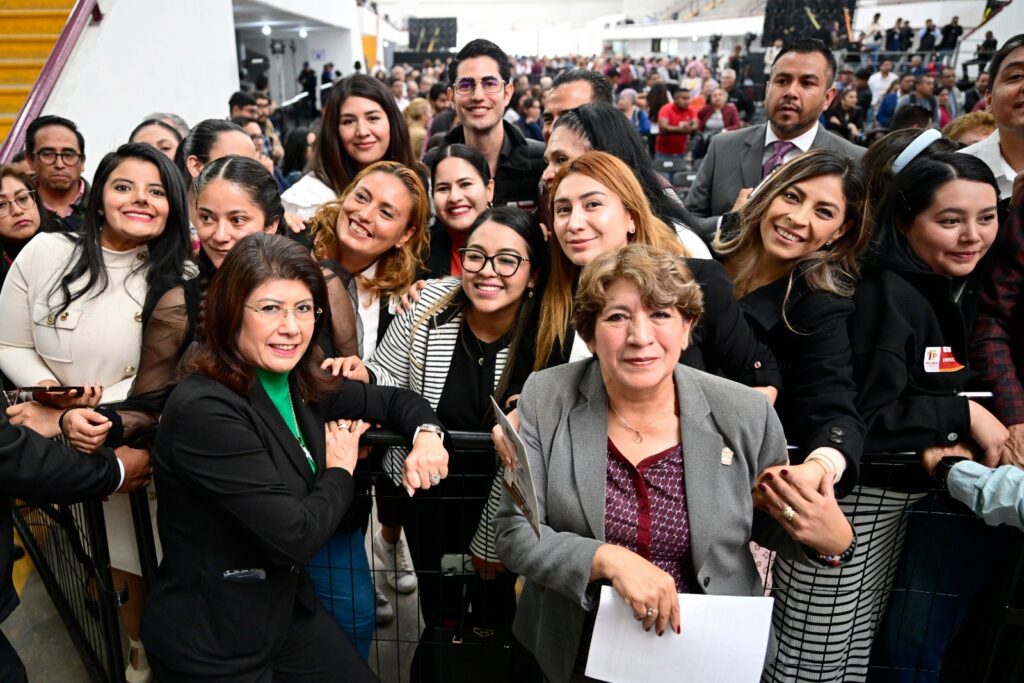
[534,152,688,370]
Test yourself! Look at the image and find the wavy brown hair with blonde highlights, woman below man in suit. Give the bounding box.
[713,150,871,297]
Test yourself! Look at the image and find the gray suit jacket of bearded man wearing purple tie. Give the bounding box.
[686,123,864,236]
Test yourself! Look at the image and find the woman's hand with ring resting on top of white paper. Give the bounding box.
[590,543,681,636]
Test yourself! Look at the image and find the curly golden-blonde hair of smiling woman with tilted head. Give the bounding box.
[309,161,430,296]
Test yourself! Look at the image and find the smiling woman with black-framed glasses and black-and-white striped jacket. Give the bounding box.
[335,207,548,680]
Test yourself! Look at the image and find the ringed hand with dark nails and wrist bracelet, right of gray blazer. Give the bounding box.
[757,463,853,555]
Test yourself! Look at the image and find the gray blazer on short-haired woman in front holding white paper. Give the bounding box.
[495,358,808,682]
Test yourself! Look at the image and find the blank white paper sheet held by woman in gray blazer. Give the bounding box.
[587,586,773,683]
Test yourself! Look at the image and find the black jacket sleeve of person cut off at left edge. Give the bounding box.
[0,411,121,623]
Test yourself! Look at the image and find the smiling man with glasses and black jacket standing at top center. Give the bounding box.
[423,38,545,210]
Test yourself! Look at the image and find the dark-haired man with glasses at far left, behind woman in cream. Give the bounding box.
[25,116,89,232]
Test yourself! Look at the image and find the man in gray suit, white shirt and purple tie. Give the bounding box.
[686,40,864,239]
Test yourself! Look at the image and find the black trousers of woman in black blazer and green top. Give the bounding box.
[146,602,377,683]
